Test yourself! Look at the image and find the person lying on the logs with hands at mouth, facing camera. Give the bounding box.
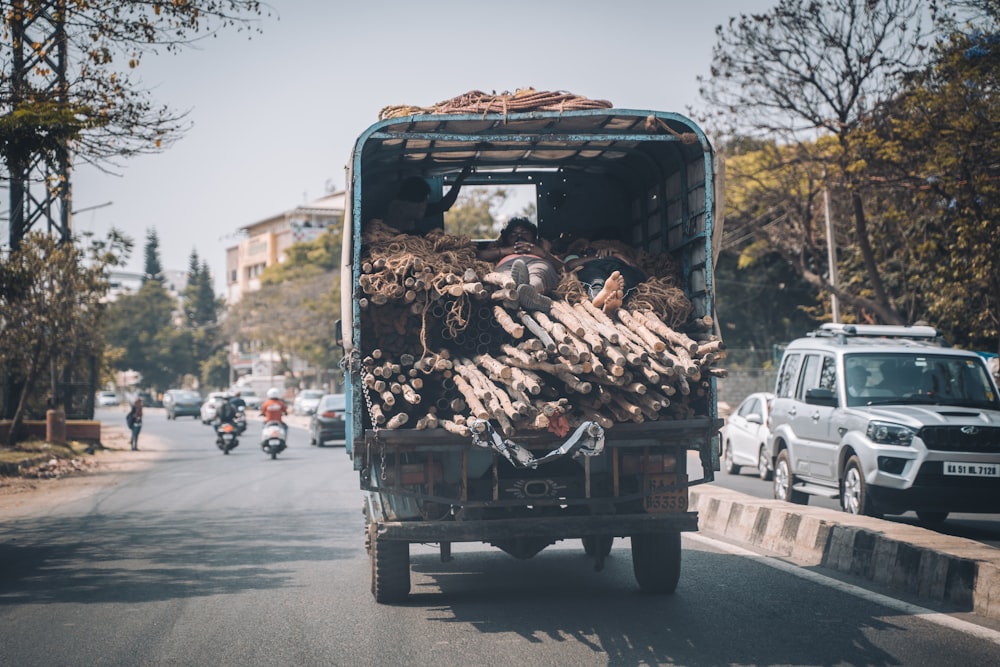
[478,217,562,312]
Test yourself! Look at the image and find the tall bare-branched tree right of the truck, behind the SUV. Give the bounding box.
[702,0,925,323]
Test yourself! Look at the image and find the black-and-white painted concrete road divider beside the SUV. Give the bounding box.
[690,485,1000,618]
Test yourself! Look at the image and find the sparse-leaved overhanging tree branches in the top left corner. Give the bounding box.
[0,0,270,168]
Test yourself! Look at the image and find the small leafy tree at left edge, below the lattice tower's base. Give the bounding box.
[0,231,131,444]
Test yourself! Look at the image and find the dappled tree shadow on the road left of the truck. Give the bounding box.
[0,510,364,605]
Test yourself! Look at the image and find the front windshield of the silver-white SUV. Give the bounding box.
[844,353,1000,409]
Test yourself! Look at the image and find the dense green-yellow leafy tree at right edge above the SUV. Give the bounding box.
[862,0,1000,350]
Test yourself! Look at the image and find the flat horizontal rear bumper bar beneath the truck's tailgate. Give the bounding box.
[376,512,698,542]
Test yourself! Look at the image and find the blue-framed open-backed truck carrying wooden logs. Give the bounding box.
[337,86,725,603]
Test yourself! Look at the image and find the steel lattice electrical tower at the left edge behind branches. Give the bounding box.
[5,0,72,250]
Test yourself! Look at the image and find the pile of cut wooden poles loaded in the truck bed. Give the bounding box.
[356,224,725,436]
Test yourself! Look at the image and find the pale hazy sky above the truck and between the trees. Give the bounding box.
[64,0,777,295]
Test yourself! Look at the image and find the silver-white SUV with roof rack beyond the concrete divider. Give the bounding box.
[768,324,1000,523]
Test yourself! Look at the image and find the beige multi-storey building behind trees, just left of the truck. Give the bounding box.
[226,192,346,303]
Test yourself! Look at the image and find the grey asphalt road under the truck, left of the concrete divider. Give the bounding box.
[0,410,1000,666]
